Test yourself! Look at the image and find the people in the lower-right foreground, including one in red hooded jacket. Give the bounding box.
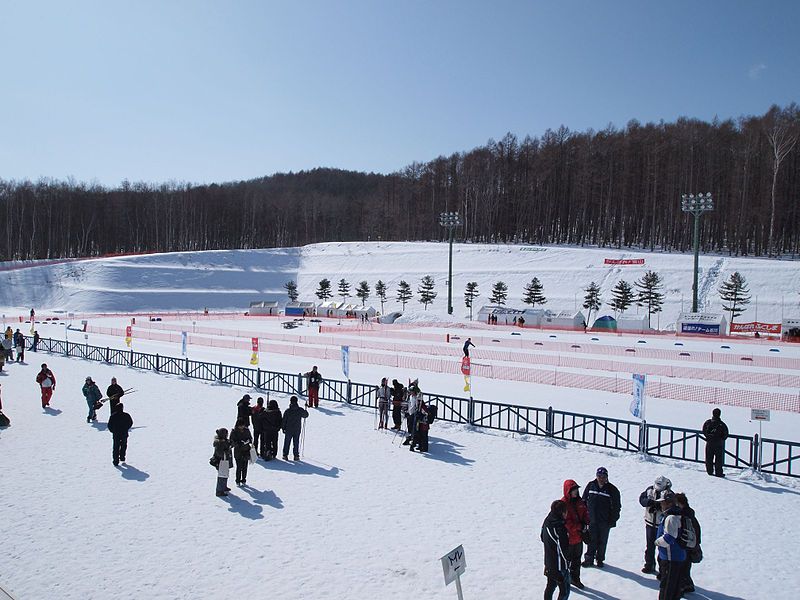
[540,467,702,600]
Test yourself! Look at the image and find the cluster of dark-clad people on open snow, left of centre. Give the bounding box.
[209,394,308,496]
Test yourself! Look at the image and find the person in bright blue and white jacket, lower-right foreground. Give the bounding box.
[656,490,686,600]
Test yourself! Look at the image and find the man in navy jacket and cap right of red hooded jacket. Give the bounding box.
[582,467,622,569]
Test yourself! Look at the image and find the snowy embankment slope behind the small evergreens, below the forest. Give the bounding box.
[0,242,800,329]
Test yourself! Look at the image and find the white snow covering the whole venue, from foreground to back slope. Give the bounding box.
[0,244,800,600]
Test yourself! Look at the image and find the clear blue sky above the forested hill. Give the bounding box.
[0,0,800,186]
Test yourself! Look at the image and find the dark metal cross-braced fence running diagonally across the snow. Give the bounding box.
[29,338,800,477]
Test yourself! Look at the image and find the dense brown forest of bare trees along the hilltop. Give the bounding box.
[0,104,800,260]
